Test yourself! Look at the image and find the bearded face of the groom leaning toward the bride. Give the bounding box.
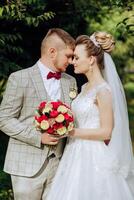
[54,46,73,72]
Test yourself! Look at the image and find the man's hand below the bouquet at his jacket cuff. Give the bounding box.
[41,133,59,145]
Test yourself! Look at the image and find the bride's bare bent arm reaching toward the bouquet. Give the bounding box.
[70,90,114,140]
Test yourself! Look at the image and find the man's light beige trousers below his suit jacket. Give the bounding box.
[11,156,59,200]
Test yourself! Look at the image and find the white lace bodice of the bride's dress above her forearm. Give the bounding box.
[72,82,110,128]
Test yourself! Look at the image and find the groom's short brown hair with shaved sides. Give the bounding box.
[41,28,75,51]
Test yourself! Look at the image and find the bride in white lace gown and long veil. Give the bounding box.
[47,32,134,200]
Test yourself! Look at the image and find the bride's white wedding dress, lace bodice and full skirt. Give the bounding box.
[47,82,134,200]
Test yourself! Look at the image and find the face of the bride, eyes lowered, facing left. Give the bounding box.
[73,44,89,74]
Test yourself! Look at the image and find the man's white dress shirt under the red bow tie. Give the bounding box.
[37,60,61,101]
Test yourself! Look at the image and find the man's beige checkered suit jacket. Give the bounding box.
[0,64,76,177]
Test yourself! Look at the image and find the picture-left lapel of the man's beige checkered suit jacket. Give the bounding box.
[29,64,50,101]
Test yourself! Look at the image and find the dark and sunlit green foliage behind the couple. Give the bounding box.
[0,0,134,200]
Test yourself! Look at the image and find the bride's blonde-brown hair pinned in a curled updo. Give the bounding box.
[76,32,115,69]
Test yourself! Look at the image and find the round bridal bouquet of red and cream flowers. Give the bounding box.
[35,101,74,136]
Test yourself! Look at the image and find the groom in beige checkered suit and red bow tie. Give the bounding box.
[0,28,76,200]
